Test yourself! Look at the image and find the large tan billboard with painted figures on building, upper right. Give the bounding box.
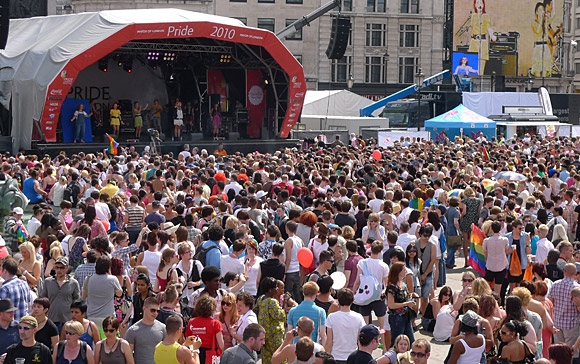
[453,0,563,77]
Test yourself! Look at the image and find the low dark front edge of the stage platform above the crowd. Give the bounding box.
[26,134,302,157]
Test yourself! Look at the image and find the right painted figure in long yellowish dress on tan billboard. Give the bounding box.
[532,2,552,77]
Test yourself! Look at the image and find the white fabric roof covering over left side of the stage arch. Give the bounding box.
[0,9,244,150]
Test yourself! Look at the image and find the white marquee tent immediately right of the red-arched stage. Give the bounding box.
[302,90,383,117]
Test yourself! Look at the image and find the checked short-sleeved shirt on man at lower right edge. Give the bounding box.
[548,277,580,330]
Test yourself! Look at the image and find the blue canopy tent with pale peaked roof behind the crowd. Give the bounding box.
[425,105,496,142]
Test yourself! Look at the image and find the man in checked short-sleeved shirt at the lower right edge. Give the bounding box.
[548,263,580,358]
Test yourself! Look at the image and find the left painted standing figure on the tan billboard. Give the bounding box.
[468,0,497,73]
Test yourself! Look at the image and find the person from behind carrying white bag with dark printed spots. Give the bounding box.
[353,241,389,328]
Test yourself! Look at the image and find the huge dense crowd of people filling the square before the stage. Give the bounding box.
[0,135,580,364]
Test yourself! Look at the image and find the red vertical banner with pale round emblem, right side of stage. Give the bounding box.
[246,70,266,138]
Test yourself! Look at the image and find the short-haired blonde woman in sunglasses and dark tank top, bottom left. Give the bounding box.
[52,321,95,364]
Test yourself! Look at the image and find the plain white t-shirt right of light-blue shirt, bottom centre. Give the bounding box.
[326,311,366,360]
